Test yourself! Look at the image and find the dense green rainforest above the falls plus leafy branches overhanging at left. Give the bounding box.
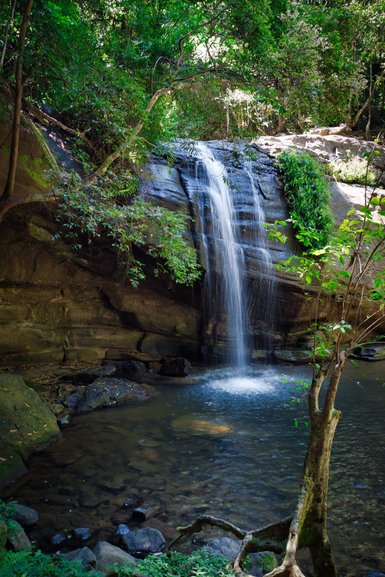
[0,0,385,285]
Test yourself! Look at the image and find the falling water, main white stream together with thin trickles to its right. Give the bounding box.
[195,143,275,368]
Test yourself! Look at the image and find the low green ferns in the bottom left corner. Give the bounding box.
[0,551,101,577]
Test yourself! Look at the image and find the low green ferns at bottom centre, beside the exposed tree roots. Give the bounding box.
[118,549,235,577]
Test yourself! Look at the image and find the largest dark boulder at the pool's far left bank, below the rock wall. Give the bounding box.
[77,377,150,413]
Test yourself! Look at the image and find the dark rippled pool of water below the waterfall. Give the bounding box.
[8,363,385,576]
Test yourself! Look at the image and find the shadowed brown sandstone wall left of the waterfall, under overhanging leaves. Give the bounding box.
[0,209,200,366]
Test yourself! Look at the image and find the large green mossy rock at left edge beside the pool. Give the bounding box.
[0,373,59,487]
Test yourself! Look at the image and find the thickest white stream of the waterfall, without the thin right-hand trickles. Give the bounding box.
[195,142,247,367]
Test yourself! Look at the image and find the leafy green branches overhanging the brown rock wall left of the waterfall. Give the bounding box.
[57,175,200,287]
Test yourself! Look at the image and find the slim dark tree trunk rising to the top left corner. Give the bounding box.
[2,0,33,201]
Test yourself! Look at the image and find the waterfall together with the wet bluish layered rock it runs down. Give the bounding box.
[146,140,280,364]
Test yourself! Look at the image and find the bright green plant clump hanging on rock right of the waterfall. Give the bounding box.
[277,151,333,249]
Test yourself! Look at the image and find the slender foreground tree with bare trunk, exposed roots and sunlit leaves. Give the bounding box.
[170,149,385,577]
